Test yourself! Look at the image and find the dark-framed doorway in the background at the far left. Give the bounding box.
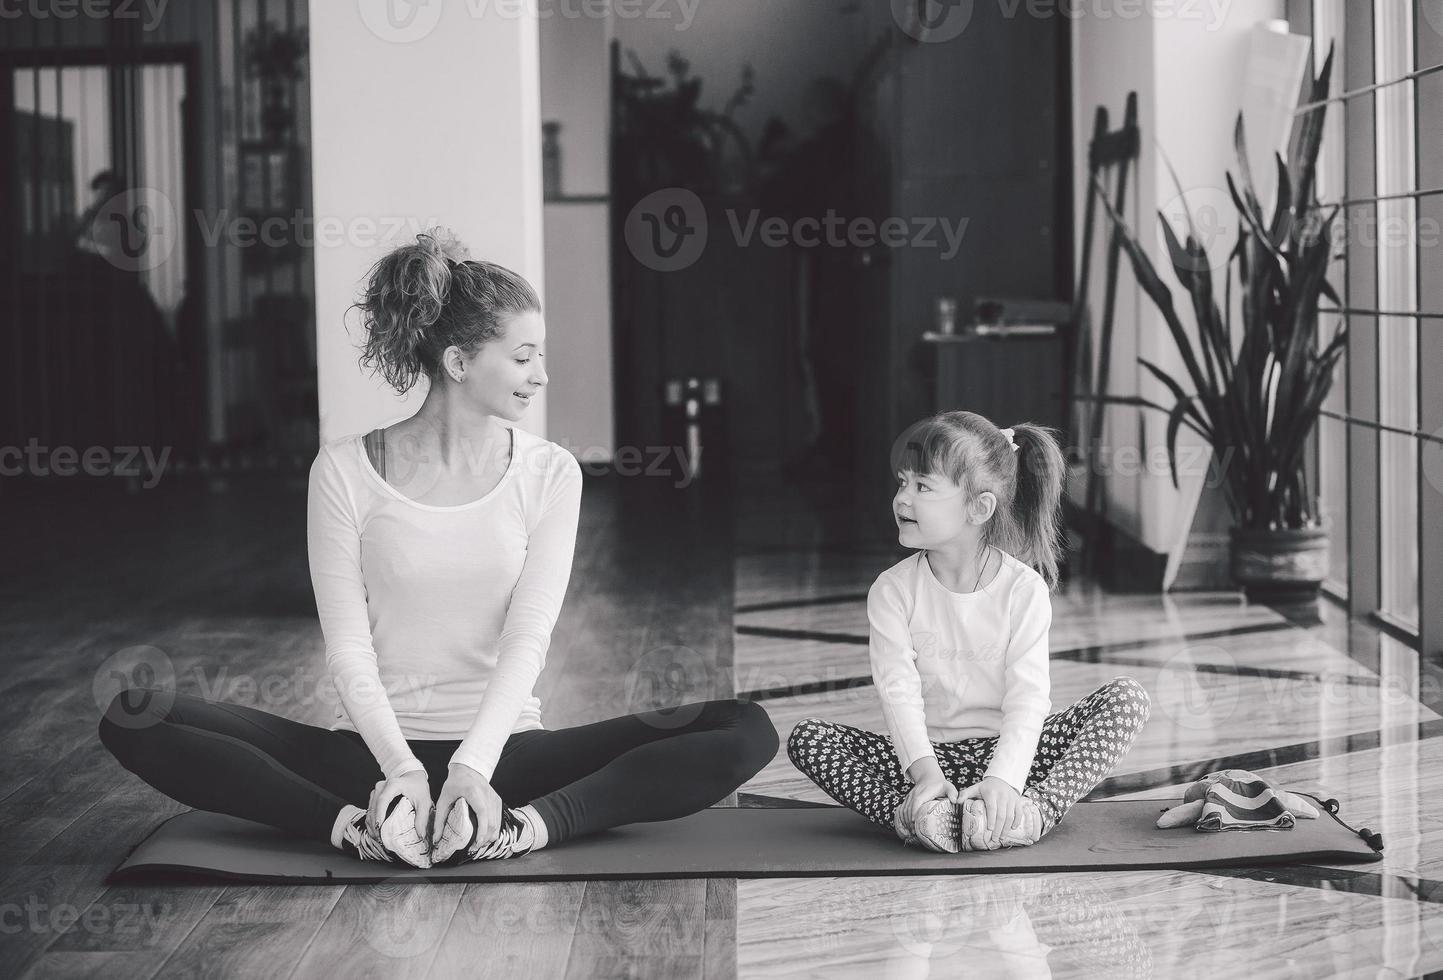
[0,46,202,464]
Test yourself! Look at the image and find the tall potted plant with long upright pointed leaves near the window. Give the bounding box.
[1100,51,1346,602]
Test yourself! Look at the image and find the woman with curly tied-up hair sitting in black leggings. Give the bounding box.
[101,234,778,867]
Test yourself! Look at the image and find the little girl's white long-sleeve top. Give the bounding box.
[867,551,1052,792]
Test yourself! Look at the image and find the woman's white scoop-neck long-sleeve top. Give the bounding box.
[306,429,582,779]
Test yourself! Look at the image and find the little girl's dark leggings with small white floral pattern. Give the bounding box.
[786,677,1149,830]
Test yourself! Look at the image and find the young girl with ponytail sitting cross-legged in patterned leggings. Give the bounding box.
[786,411,1149,853]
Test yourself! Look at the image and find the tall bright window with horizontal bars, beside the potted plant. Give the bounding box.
[1289,0,1443,638]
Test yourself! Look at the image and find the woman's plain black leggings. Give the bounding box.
[100,690,778,841]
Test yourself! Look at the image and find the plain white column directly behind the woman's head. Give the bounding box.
[310,0,547,442]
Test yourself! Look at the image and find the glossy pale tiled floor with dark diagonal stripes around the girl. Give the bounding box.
[734,476,1443,977]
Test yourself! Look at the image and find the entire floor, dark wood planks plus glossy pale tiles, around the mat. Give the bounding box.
[0,478,1443,980]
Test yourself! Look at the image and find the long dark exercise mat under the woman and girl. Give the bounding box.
[111,800,1381,885]
